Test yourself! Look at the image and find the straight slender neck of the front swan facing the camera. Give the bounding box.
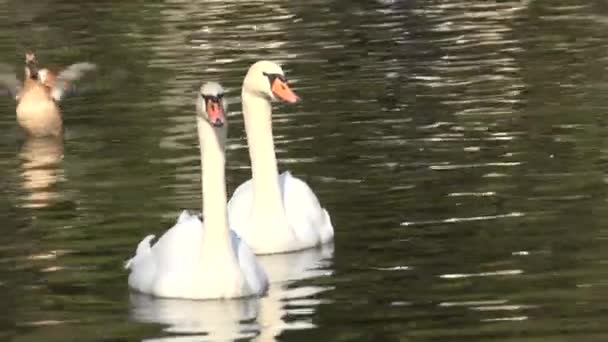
[197,118,230,246]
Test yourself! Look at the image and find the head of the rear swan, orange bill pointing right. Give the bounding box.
[243,61,300,103]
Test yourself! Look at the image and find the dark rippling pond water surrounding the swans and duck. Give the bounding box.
[0,0,608,341]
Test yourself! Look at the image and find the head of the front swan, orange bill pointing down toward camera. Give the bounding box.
[196,82,227,127]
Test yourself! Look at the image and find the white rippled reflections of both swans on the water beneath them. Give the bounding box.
[130,245,334,341]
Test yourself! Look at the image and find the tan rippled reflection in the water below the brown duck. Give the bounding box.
[19,138,63,208]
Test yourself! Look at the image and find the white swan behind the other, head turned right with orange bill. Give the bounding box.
[228,61,334,254]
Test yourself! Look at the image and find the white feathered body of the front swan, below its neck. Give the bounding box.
[125,211,268,299]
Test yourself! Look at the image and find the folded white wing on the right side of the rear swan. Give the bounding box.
[279,171,334,244]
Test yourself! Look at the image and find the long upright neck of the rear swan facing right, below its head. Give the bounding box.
[242,90,284,214]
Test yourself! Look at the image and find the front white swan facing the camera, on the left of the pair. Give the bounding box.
[125,82,268,299]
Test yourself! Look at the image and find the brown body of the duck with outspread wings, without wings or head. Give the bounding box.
[17,77,63,137]
